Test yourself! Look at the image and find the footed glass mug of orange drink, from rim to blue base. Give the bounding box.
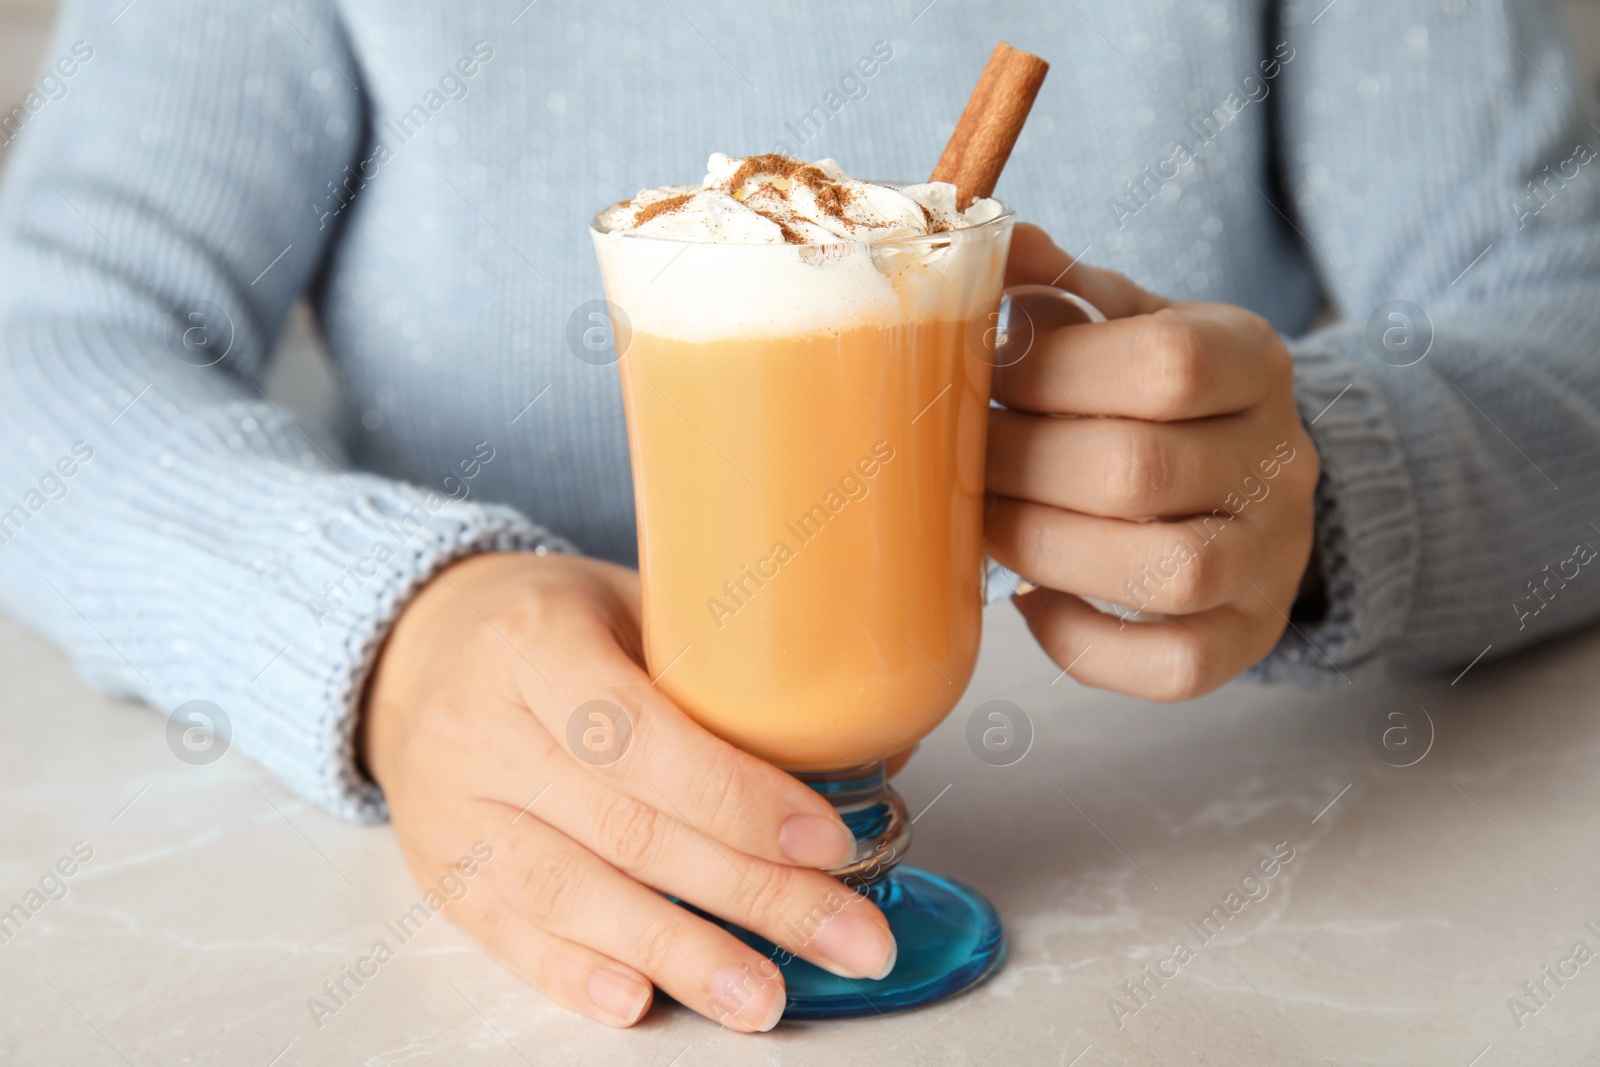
[592,189,1014,1019]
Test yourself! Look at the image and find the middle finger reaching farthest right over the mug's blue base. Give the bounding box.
[534,776,896,979]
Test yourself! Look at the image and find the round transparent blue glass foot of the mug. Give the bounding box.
[723,867,1005,1019]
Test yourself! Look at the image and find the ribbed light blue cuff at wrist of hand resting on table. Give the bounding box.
[237,489,573,822]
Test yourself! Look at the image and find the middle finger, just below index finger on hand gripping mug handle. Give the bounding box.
[984,408,1291,518]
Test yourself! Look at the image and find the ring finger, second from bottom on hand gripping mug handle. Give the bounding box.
[984,496,1269,614]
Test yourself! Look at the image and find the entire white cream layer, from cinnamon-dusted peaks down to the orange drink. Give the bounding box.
[590,154,1011,342]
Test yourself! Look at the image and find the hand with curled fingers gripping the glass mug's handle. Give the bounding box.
[986,226,1318,701]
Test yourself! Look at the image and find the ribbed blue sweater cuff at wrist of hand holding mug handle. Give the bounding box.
[1248,325,1421,685]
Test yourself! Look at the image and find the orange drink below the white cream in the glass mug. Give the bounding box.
[621,318,989,771]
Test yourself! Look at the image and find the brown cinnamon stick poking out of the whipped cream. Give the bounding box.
[930,42,1050,211]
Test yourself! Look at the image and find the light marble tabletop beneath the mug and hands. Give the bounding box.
[0,605,1600,1067]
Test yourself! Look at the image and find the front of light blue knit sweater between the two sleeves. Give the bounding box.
[309,0,1318,560]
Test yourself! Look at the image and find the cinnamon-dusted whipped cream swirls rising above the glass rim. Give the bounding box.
[597,152,1002,245]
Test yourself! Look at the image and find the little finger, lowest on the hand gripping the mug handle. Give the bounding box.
[1016,589,1285,702]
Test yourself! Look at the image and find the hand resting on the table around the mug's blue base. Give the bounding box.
[362,553,894,1030]
